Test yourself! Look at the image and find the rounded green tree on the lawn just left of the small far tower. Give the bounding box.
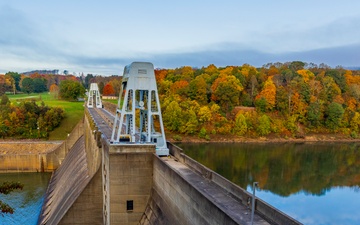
[59,80,85,101]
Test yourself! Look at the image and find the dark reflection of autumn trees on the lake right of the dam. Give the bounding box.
[179,143,360,196]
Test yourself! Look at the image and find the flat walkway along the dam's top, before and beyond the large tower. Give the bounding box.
[88,108,270,225]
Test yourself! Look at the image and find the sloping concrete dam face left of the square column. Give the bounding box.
[38,112,103,225]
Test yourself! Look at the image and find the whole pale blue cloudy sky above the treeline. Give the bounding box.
[0,0,360,75]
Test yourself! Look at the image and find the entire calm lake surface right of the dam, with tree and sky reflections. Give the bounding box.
[178,143,360,225]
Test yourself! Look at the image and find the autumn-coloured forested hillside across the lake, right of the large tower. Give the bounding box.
[155,61,360,139]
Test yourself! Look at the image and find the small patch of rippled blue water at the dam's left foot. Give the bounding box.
[0,173,51,225]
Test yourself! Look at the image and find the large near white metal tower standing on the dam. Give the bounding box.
[111,62,169,155]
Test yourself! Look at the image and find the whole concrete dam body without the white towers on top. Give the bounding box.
[39,109,301,225]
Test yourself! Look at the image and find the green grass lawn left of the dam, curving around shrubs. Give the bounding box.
[8,92,84,140]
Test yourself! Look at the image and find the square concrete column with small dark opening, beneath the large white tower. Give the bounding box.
[103,144,155,225]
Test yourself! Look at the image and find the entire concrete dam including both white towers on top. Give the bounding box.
[38,63,301,225]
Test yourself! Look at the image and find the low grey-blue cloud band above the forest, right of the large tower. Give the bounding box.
[148,44,360,67]
